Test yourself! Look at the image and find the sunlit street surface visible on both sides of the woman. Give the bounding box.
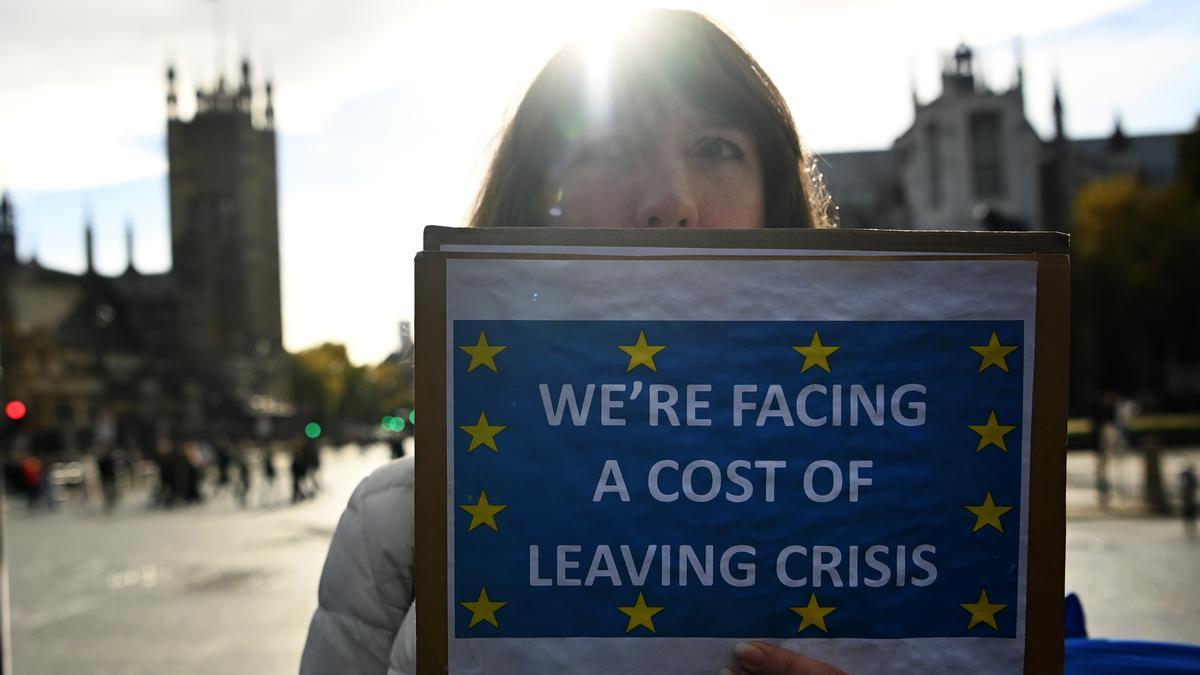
[5,446,1200,675]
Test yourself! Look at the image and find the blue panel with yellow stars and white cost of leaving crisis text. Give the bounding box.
[448,321,1026,639]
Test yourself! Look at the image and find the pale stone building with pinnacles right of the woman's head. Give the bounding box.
[820,44,1178,232]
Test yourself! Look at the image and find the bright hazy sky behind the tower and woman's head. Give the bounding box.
[0,0,1200,363]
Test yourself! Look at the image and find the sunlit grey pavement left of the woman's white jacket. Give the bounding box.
[5,446,390,675]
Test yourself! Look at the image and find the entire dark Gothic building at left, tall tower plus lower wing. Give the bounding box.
[0,56,289,452]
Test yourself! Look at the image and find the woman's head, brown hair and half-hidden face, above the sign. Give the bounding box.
[470,10,830,227]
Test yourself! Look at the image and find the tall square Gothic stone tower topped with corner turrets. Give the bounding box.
[167,61,286,408]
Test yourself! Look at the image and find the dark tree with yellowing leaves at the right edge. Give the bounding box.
[1072,132,1200,404]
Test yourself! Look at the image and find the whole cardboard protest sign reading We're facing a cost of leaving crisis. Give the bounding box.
[416,231,1067,673]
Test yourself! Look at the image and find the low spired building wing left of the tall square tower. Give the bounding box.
[0,201,177,452]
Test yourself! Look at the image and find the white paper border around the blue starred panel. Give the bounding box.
[445,254,1038,674]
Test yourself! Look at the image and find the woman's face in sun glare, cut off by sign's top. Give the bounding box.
[546,91,764,228]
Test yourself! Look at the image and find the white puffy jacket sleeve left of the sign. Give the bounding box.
[300,455,416,675]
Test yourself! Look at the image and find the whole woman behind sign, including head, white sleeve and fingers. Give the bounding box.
[301,10,839,675]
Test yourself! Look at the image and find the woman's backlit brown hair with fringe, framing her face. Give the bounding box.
[470,10,832,227]
